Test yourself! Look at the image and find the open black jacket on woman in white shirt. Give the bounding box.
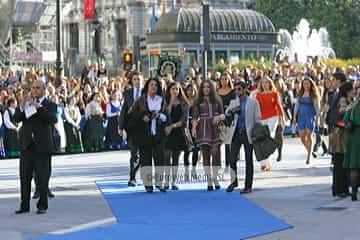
[128,95,168,146]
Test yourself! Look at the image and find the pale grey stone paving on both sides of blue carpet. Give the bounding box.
[0,139,360,240]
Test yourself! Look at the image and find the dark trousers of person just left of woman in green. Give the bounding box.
[332,153,350,195]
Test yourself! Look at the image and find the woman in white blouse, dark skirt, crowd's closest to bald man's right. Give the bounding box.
[64,97,84,153]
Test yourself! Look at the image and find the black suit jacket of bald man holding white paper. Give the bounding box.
[14,99,57,153]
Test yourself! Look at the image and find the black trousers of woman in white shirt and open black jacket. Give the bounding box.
[139,137,164,187]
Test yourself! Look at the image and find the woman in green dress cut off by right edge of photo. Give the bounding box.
[344,92,360,201]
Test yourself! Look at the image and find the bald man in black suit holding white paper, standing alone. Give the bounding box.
[14,80,57,214]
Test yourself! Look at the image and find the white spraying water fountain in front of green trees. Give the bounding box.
[276,19,336,63]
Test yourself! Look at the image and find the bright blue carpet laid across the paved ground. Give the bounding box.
[34,180,291,240]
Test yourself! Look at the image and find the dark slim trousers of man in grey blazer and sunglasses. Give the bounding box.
[230,129,254,189]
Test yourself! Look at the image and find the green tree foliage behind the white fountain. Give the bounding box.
[256,0,360,58]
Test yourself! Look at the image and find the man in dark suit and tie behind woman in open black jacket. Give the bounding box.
[119,73,143,187]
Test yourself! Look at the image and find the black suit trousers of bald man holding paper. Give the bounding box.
[20,148,51,209]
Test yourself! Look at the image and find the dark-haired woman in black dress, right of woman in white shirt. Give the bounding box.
[165,82,189,190]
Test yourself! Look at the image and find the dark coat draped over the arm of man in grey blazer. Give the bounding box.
[252,123,277,161]
